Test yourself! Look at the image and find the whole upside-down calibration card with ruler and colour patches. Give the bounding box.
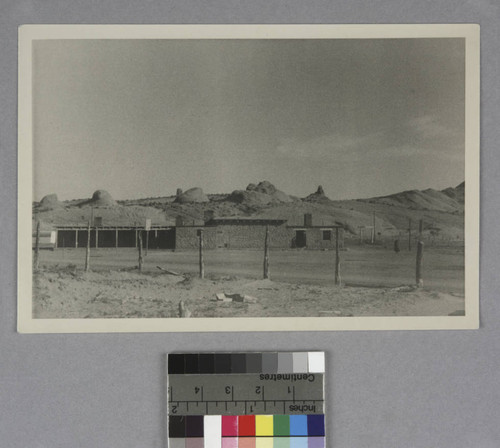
[167,352,325,448]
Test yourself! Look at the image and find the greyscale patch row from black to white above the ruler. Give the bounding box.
[168,352,325,374]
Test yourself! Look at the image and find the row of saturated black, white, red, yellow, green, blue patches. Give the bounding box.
[168,414,325,438]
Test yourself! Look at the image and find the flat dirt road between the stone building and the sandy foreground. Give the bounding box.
[40,246,464,294]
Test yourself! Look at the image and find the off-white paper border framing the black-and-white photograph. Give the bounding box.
[17,24,480,333]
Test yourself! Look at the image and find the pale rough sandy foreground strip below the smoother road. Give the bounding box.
[33,269,464,318]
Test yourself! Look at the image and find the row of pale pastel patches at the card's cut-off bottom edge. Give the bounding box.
[168,437,325,448]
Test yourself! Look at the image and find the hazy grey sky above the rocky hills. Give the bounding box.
[33,38,465,200]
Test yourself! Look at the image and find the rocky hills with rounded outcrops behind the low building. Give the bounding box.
[33,181,465,240]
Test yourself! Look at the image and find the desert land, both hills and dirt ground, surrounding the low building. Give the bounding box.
[33,181,464,318]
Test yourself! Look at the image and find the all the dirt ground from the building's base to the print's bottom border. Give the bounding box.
[33,248,464,318]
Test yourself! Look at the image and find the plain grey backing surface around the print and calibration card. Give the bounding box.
[0,0,500,448]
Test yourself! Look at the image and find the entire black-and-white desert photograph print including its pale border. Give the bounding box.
[18,25,479,332]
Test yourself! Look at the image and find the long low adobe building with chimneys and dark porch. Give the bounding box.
[46,214,344,250]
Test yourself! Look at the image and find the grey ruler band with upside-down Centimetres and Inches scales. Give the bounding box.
[168,373,324,415]
